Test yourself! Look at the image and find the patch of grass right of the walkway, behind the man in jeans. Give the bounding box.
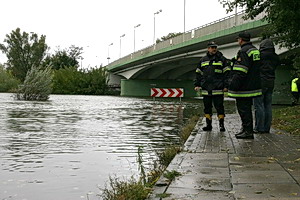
[272,105,300,135]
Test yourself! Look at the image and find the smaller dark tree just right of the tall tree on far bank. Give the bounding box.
[44,45,83,70]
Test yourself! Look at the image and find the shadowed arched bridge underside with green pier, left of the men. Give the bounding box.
[115,56,200,97]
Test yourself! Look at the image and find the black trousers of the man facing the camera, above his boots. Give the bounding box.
[203,95,225,115]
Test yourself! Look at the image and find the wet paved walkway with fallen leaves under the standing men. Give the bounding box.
[149,114,300,200]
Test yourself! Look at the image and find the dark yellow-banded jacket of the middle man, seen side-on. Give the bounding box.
[228,42,262,97]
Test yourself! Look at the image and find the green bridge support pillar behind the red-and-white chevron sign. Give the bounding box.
[121,79,196,97]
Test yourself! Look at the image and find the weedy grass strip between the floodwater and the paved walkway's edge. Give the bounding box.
[100,116,199,200]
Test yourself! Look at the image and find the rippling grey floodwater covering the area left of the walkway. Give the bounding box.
[0,94,236,200]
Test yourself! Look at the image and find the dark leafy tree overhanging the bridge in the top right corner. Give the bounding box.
[219,0,300,76]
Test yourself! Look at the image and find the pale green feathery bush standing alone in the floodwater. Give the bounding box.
[15,66,53,101]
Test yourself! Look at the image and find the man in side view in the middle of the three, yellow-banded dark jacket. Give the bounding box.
[228,32,262,139]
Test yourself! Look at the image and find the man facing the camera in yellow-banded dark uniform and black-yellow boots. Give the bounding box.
[194,42,230,131]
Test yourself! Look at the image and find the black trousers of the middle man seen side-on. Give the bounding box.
[236,97,253,132]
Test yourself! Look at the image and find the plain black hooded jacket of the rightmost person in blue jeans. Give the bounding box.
[259,39,280,88]
